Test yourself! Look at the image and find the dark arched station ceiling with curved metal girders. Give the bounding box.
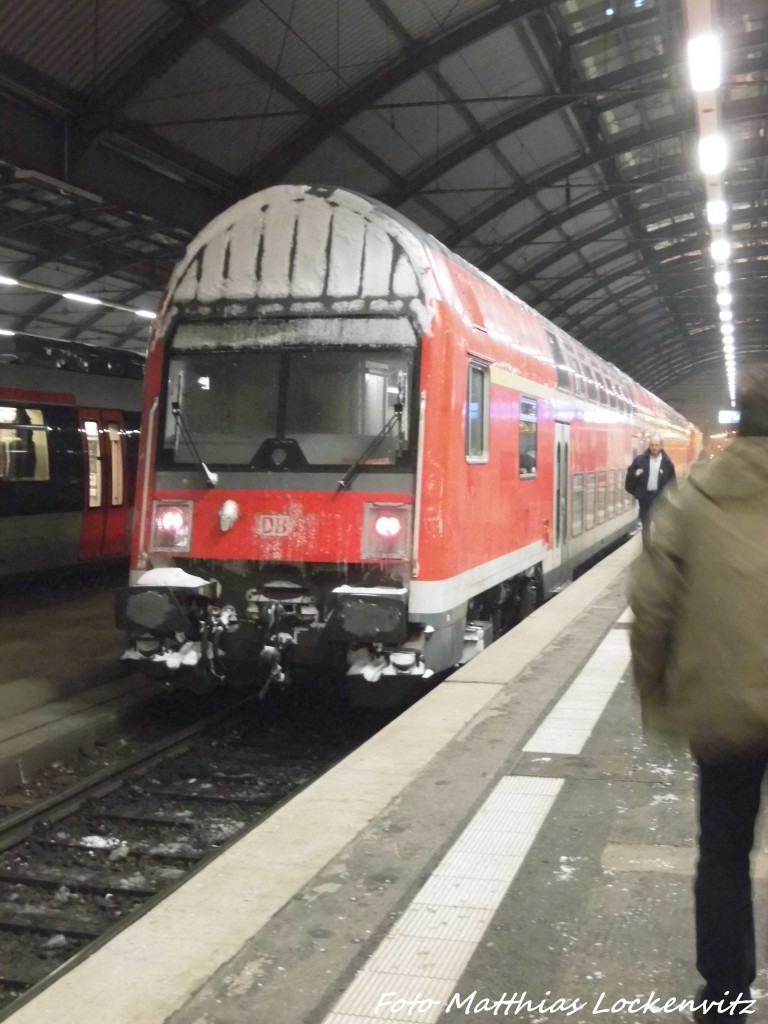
[0,0,768,425]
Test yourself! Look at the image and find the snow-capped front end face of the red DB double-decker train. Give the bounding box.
[117,186,433,691]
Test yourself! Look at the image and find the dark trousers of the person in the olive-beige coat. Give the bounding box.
[694,755,768,1007]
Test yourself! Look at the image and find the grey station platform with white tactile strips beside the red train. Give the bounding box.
[9,537,768,1024]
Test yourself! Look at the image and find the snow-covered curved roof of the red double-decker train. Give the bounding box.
[162,184,686,426]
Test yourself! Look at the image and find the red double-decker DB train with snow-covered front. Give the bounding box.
[118,185,699,702]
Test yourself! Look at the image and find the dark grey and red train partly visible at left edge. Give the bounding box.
[0,334,144,579]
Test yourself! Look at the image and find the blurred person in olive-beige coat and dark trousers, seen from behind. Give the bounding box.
[629,373,768,1021]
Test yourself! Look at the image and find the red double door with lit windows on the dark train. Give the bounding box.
[80,409,128,560]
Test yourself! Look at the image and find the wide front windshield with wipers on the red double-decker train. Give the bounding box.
[163,317,417,469]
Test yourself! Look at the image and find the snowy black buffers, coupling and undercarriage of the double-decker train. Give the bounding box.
[116,562,544,706]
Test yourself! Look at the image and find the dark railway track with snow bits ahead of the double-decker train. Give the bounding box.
[0,688,391,1020]
